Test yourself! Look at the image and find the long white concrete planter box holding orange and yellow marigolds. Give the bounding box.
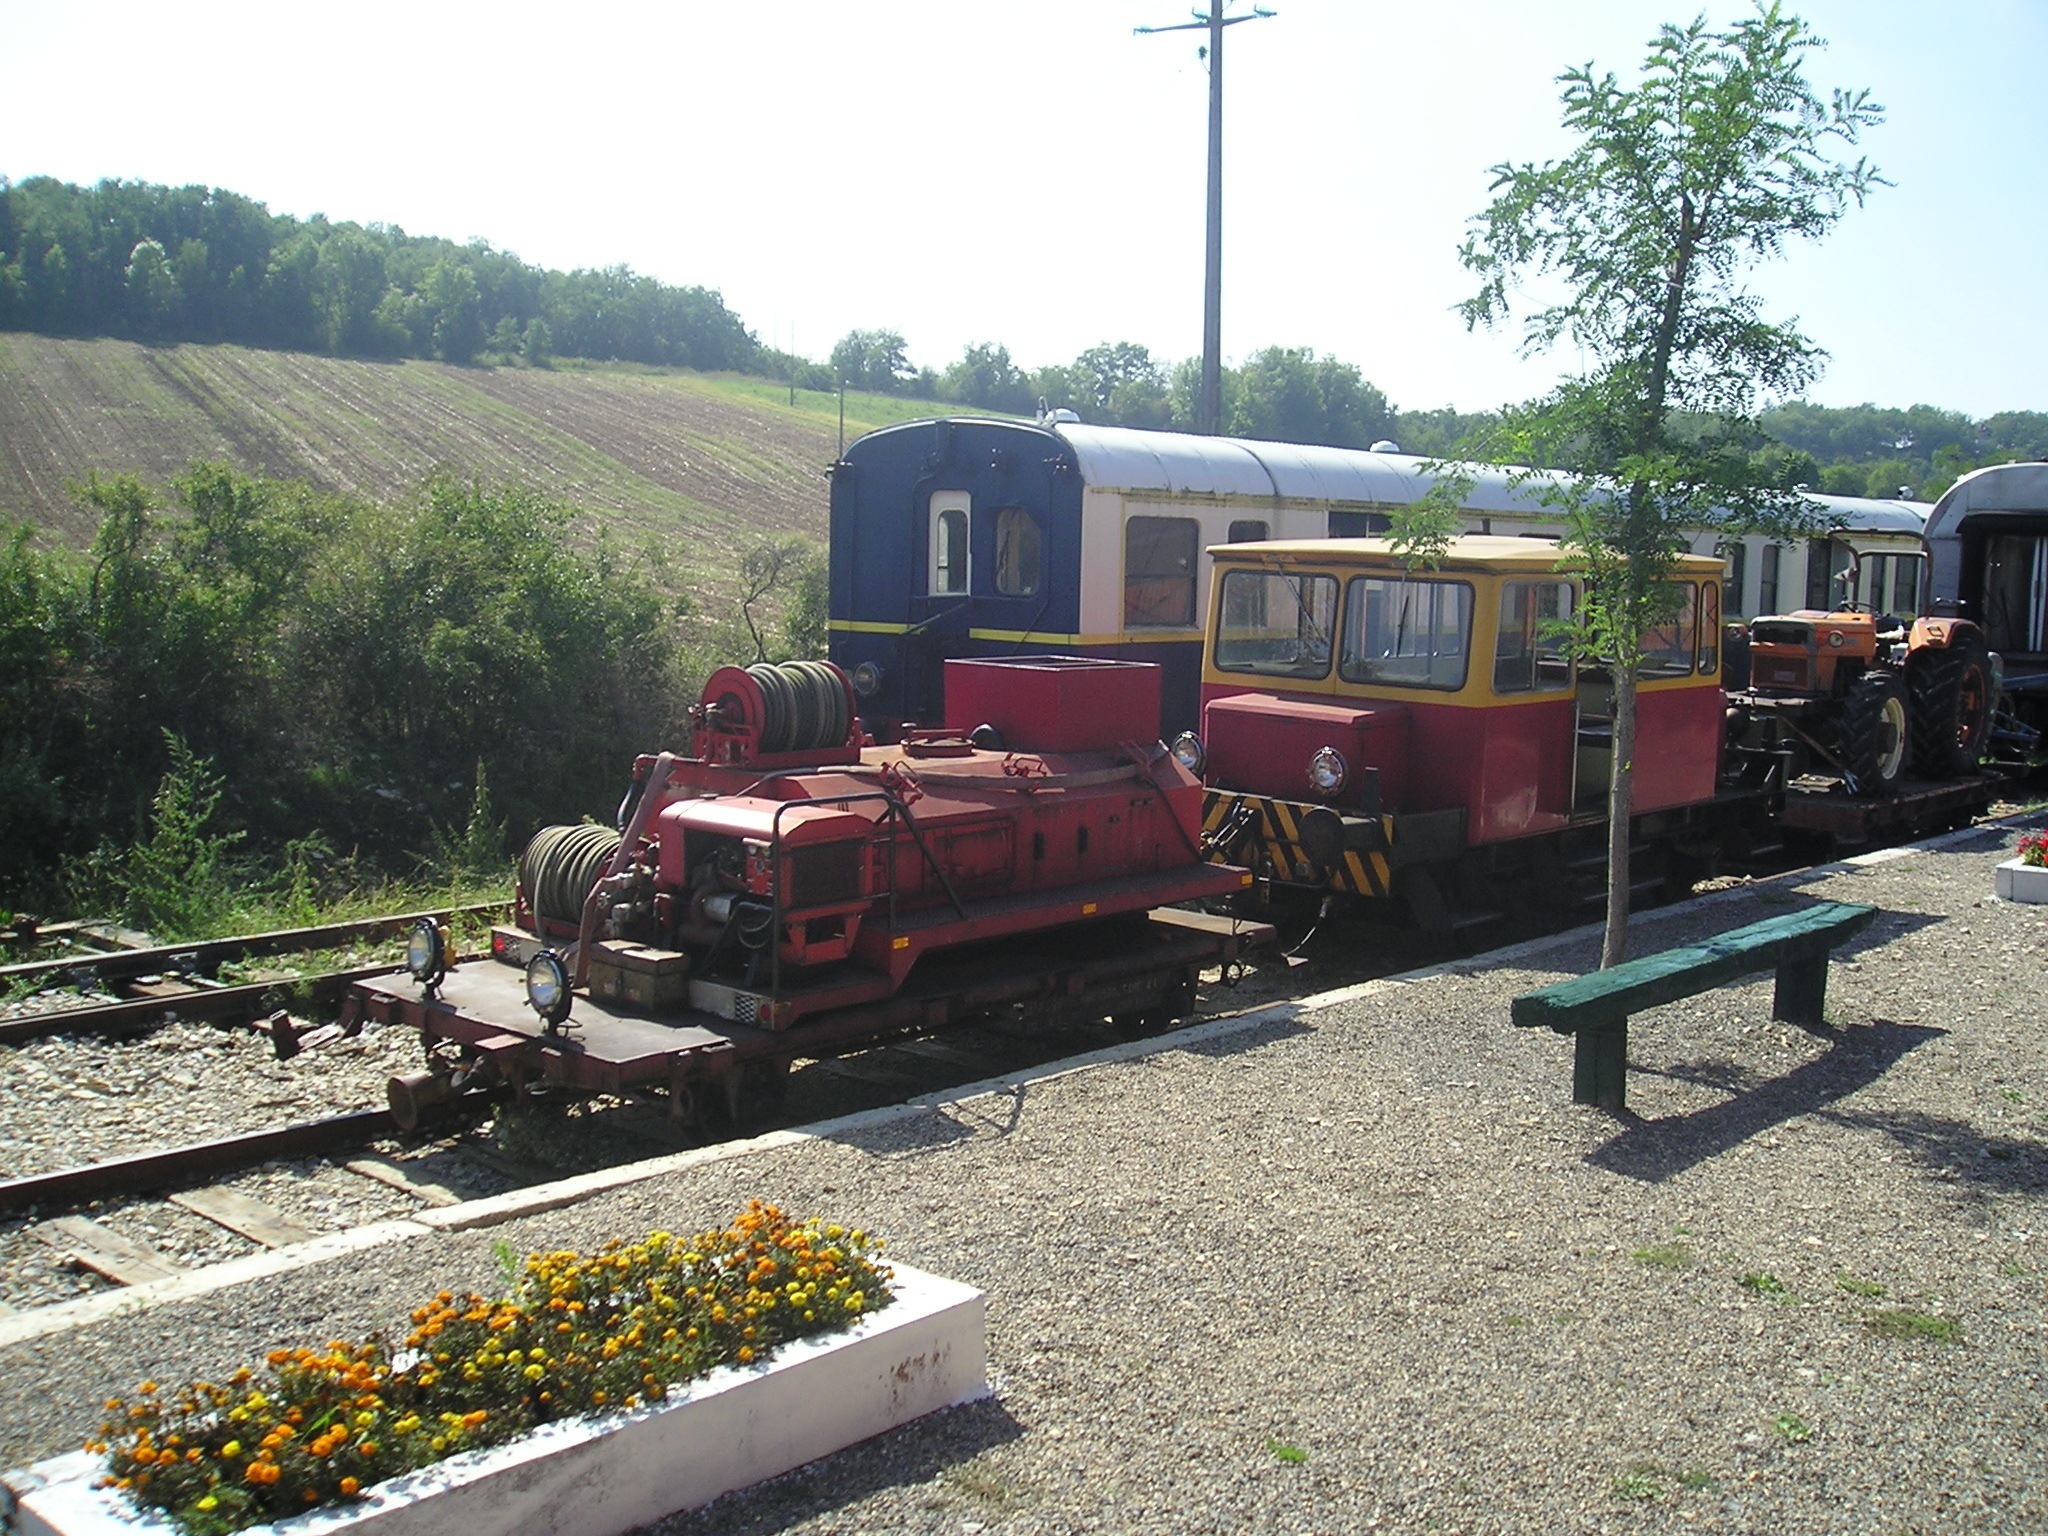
[0,1264,989,1536]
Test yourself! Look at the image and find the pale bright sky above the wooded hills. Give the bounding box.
[0,0,2048,416]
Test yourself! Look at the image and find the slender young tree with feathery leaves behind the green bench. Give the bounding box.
[1397,4,1884,967]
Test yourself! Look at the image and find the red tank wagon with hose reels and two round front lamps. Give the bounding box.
[342,655,1270,1128]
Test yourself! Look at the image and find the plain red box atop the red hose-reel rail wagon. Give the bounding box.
[946,655,1159,752]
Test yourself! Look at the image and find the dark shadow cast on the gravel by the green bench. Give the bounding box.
[1585,1018,1941,1184]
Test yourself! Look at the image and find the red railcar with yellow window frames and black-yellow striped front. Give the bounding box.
[1176,537,1755,930]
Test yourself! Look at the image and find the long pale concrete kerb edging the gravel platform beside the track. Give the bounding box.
[0,811,2048,1350]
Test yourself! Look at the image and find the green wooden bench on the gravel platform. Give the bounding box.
[1513,901,1878,1110]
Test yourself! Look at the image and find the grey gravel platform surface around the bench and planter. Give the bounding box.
[0,834,2048,1536]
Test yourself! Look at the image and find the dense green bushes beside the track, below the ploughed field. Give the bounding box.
[0,465,823,921]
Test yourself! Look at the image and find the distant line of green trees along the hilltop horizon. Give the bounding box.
[0,176,2048,500]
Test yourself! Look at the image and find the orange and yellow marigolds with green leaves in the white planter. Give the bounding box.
[88,1200,891,1536]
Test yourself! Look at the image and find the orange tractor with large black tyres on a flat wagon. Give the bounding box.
[1729,604,1997,795]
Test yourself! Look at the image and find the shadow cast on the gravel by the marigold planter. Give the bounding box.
[645,1397,1030,1536]
